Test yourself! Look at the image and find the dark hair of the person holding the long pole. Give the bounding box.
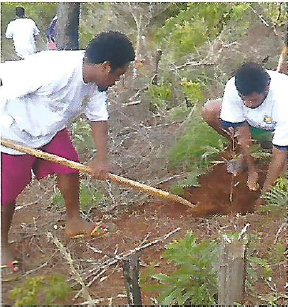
[85,31,135,71]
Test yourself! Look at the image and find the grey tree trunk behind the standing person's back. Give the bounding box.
[56,2,80,50]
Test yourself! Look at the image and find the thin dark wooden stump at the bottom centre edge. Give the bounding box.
[122,254,142,305]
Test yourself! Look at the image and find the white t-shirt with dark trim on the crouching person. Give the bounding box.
[220,70,288,146]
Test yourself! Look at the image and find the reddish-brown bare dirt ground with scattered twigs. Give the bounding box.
[2,158,287,304]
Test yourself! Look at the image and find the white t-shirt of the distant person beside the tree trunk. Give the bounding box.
[6,18,39,58]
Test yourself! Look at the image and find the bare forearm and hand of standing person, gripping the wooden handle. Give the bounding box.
[88,121,109,180]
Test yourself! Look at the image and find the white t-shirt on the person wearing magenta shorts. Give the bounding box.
[0,50,108,154]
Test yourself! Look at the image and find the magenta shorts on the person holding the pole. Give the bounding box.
[1,129,79,206]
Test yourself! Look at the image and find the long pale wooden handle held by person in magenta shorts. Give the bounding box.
[1,139,194,208]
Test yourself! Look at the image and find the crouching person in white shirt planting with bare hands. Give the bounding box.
[202,62,288,206]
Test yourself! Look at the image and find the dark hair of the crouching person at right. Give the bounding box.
[235,62,270,96]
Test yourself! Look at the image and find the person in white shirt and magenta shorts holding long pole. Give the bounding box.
[0,31,135,278]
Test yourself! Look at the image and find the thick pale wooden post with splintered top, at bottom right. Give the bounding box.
[218,224,249,305]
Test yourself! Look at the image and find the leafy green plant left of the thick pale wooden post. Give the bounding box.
[142,232,218,305]
